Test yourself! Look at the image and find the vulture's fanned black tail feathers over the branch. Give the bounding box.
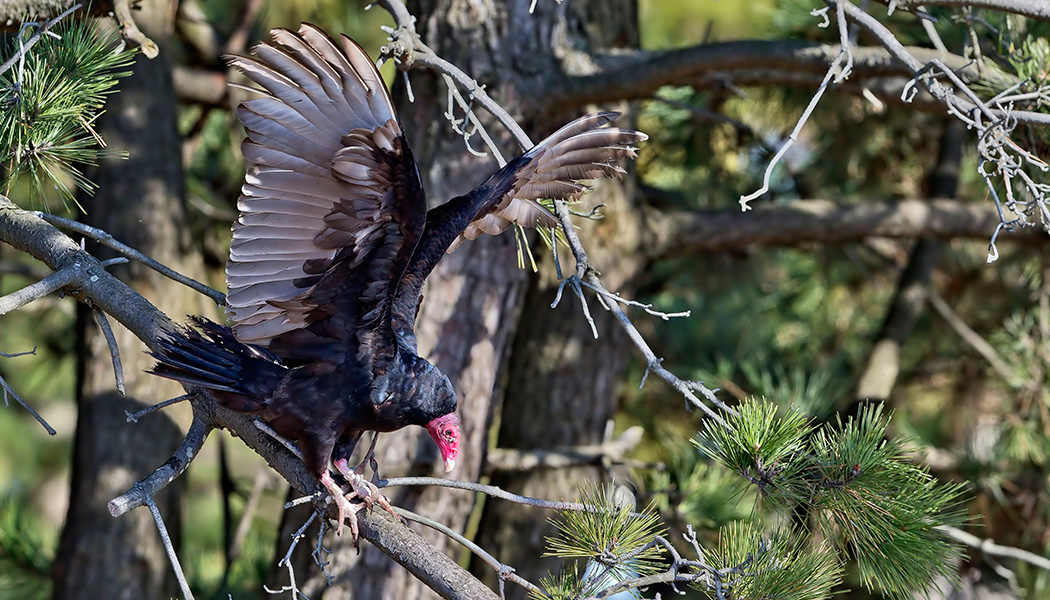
[149,317,289,412]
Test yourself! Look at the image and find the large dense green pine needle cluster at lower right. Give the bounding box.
[697,399,963,598]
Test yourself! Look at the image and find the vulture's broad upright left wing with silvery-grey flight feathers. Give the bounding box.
[226,24,426,361]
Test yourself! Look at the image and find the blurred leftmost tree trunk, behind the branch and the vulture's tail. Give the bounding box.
[54,0,205,600]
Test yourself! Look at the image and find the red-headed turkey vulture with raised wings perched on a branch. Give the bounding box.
[152,24,646,539]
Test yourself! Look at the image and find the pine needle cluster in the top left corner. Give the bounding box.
[0,21,134,211]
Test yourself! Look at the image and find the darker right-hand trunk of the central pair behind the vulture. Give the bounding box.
[471,0,647,598]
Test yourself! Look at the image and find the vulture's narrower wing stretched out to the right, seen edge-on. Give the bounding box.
[394,112,648,344]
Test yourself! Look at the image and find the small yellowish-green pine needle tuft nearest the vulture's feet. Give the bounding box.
[544,484,664,577]
